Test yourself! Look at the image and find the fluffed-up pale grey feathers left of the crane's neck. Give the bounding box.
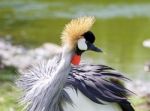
[16,54,71,111]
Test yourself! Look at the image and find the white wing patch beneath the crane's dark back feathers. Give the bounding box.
[63,88,122,111]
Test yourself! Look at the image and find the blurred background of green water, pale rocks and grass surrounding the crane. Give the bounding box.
[0,0,150,111]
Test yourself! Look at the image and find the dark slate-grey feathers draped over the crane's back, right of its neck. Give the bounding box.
[66,64,130,104]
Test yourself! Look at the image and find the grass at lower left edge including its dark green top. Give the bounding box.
[0,67,21,111]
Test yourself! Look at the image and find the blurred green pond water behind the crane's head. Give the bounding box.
[0,0,150,80]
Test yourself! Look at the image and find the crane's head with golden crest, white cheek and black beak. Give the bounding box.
[61,16,101,52]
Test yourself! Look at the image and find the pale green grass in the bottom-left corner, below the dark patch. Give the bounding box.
[0,82,22,111]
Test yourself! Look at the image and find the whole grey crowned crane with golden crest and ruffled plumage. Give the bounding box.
[17,16,134,111]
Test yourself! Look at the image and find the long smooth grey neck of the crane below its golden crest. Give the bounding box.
[44,47,73,111]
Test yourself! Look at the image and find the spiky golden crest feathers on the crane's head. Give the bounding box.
[61,16,95,49]
